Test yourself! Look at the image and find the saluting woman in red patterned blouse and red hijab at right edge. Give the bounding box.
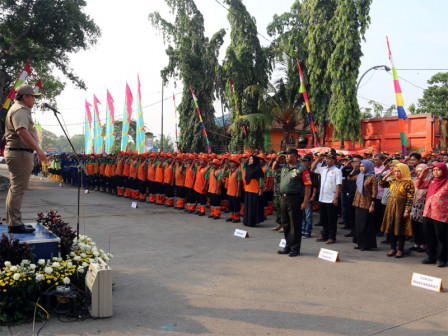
[416,162,448,267]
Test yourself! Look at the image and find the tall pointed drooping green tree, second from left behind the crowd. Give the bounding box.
[220,0,270,152]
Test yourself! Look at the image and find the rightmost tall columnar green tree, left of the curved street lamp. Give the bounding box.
[327,0,371,148]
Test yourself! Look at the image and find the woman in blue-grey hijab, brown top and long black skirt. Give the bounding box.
[353,160,378,251]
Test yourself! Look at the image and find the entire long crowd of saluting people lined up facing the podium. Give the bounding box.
[39,149,448,267]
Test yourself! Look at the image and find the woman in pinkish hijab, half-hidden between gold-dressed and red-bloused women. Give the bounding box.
[410,163,430,252]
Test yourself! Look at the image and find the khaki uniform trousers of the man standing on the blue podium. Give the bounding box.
[5,149,34,226]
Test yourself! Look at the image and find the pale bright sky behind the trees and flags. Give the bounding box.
[34,0,448,138]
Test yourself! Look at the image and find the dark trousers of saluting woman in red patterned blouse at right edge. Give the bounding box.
[423,217,448,262]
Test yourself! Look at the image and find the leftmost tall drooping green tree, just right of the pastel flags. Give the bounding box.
[149,0,225,152]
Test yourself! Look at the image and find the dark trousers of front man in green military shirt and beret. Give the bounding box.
[280,195,303,252]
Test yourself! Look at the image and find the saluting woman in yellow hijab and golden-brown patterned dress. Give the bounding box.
[380,163,415,258]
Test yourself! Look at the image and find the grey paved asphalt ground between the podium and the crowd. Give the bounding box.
[0,165,448,336]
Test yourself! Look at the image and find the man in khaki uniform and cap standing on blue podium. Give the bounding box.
[5,84,46,233]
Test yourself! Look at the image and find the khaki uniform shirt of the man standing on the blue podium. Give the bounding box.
[5,101,39,149]
